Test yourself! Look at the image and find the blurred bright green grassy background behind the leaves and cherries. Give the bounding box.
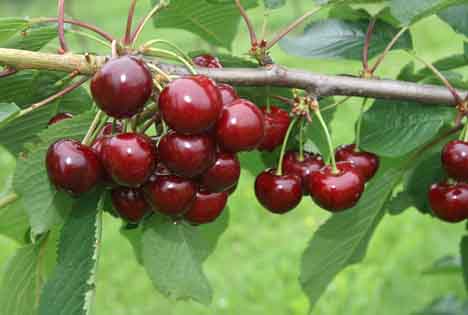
[0,0,465,315]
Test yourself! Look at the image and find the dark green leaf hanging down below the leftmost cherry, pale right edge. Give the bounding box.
[38,193,102,315]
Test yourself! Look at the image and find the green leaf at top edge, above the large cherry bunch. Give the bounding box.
[152,0,258,49]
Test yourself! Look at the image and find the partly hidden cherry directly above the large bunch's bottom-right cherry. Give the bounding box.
[200,152,240,192]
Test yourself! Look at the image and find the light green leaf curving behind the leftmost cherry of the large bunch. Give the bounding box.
[14,112,94,234]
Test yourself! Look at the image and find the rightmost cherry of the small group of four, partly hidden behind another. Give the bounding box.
[335,144,380,181]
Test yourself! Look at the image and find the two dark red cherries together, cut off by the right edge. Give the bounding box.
[428,140,468,223]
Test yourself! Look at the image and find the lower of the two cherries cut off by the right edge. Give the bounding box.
[429,183,468,223]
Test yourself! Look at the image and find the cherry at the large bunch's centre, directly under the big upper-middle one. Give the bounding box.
[158,132,216,178]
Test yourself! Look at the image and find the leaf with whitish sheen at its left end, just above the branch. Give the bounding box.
[280,19,413,60]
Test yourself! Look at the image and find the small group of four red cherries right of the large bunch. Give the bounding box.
[255,145,379,214]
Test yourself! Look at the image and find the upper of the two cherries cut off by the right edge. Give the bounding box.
[442,140,468,181]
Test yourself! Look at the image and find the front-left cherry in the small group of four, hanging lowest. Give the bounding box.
[255,169,302,214]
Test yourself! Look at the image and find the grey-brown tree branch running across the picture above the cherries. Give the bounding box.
[0,48,468,106]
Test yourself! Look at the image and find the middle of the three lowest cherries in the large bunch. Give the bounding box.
[144,175,197,217]
